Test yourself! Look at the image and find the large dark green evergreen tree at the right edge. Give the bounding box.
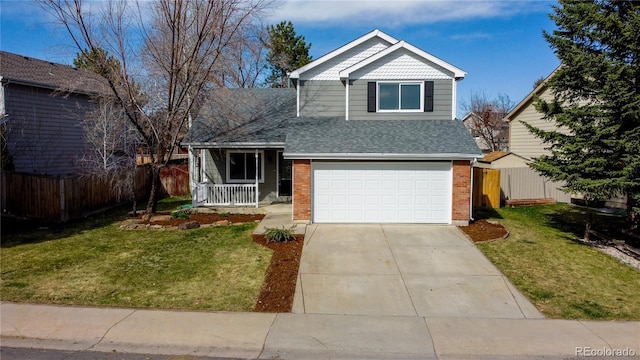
[527,0,640,229]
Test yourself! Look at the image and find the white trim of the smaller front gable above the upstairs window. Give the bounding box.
[339,41,467,79]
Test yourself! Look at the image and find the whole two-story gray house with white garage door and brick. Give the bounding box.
[182,30,481,224]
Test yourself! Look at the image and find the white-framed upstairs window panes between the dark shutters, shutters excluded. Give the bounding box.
[378,82,423,111]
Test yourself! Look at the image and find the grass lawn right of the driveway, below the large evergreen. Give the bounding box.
[478,204,640,320]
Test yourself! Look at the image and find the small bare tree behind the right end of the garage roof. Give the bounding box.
[462,93,515,151]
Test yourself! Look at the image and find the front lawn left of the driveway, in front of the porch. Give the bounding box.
[0,200,272,311]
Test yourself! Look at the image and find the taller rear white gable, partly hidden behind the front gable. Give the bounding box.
[290,29,398,80]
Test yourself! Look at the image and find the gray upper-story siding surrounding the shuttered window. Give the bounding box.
[349,79,453,120]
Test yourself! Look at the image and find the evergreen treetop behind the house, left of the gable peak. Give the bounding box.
[267,21,311,87]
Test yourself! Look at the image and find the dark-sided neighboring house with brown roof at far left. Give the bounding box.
[0,51,108,175]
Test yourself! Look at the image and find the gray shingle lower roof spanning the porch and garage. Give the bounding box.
[182,89,481,156]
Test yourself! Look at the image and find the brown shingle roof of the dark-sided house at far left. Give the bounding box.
[0,51,109,94]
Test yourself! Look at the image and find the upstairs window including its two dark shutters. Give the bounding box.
[367,81,434,112]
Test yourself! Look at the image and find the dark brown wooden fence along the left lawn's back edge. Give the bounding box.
[0,166,149,221]
